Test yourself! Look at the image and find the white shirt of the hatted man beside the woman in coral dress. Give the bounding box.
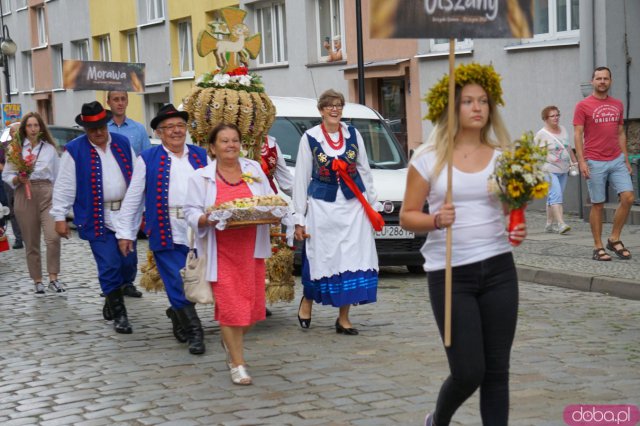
[116,144,195,246]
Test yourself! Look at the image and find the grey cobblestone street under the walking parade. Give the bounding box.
[0,234,640,426]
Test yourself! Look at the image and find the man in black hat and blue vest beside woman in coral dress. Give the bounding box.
[117,104,207,354]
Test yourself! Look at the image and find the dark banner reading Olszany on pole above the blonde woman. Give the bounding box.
[369,0,534,39]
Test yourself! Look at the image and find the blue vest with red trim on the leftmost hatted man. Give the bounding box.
[65,133,133,241]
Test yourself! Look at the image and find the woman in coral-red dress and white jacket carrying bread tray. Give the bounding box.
[185,124,273,385]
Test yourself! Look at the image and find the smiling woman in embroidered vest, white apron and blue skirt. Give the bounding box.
[293,90,384,335]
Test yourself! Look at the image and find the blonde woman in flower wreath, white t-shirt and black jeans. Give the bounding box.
[400,64,526,426]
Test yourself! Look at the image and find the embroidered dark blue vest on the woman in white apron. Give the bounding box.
[307,126,365,202]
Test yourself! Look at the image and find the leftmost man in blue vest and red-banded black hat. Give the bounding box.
[51,102,142,334]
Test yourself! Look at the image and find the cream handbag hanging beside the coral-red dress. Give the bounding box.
[180,229,214,305]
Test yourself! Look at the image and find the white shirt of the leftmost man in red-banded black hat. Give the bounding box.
[50,135,140,236]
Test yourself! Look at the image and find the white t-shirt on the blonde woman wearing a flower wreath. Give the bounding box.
[411,150,511,271]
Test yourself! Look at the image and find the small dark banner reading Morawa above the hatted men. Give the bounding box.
[62,60,144,92]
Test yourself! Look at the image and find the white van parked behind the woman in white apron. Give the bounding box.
[269,96,426,272]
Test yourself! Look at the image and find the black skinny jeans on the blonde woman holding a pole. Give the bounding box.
[427,253,518,426]
